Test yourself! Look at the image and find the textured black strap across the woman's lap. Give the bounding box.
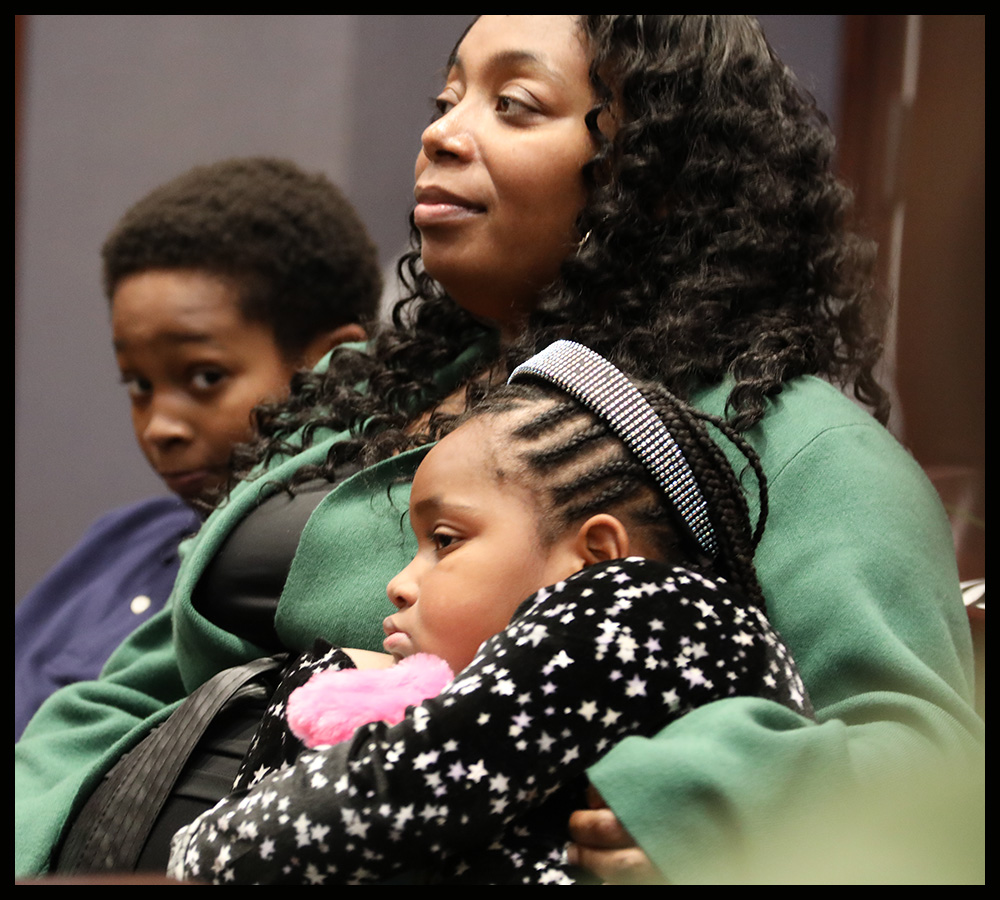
[58,655,286,872]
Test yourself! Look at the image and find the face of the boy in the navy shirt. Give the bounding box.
[111,269,296,500]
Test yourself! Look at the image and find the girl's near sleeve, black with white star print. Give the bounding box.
[171,560,805,884]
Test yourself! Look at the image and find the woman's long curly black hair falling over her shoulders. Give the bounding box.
[238,16,888,492]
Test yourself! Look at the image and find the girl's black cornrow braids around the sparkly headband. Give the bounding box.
[456,382,767,609]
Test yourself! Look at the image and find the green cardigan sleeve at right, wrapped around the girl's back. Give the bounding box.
[589,389,983,882]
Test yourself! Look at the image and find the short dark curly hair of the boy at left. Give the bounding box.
[101,157,382,359]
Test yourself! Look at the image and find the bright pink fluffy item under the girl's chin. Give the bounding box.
[286,653,455,748]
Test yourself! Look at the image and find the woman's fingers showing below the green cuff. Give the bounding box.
[568,786,666,884]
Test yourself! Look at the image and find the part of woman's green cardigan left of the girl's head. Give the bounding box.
[14,335,484,875]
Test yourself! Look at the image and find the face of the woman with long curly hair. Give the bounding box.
[414,15,595,334]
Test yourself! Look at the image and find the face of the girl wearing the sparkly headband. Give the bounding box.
[383,417,583,672]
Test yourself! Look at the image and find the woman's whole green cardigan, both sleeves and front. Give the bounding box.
[15,370,983,881]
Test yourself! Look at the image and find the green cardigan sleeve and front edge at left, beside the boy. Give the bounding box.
[14,446,336,875]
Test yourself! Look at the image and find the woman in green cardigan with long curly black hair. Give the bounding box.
[18,16,981,881]
